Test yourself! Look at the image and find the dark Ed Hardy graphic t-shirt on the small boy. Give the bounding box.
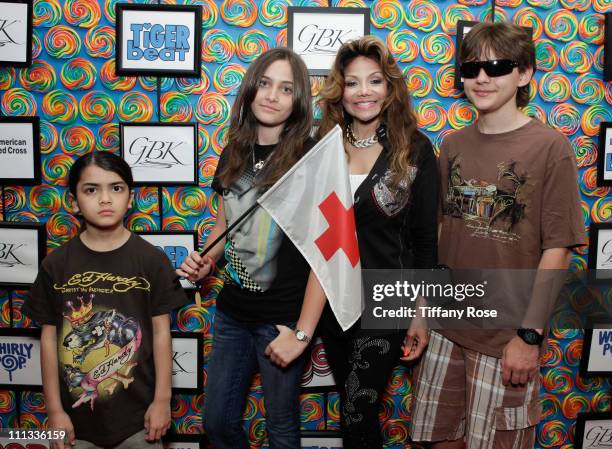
[23,234,187,446]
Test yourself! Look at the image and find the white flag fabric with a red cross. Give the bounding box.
[258,126,362,330]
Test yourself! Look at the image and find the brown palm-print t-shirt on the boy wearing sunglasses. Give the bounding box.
[439,119,586,357]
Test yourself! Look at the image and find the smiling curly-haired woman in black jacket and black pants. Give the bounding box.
[319,36,438,449]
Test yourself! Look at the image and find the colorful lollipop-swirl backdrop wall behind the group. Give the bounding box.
[0,0,612,449]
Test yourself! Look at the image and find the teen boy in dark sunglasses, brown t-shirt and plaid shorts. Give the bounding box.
[411,23,585,449]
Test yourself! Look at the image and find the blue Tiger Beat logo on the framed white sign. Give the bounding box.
[127,23,189,61]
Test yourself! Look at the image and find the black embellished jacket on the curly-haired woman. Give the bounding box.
[321,131,439,335]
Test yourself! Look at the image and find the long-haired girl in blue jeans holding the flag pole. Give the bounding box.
[177,48,325,449]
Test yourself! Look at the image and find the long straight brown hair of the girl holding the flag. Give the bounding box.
[219,48,312,186]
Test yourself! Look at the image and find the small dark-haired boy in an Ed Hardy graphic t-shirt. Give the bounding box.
[23,152,186,449]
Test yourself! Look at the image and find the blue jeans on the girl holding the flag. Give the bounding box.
[204,310,304,449]
